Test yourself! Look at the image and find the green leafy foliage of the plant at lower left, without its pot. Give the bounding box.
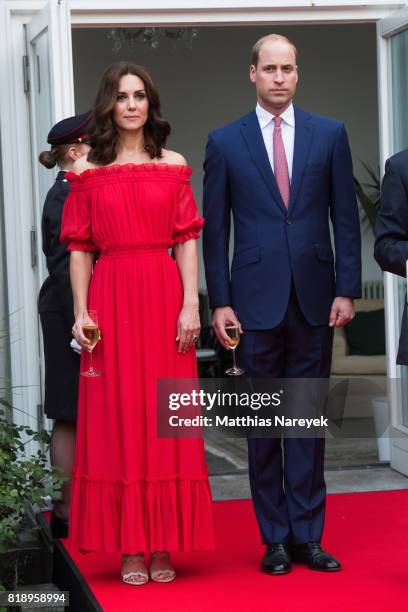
[0,398,66,554]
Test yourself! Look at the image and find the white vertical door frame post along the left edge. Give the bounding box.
[0,3,43,426]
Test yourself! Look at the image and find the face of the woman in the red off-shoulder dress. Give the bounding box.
[113,74,149,131]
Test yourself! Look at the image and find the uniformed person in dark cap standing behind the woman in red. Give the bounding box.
[38,112,91,537]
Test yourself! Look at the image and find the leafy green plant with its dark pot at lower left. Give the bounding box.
[0,397,65,589]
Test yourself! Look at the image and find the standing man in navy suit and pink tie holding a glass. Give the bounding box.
[204,34,361,574]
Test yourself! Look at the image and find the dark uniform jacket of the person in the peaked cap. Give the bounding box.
[38,172,74,326]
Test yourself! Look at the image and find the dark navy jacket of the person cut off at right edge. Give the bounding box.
[374,150,408,364]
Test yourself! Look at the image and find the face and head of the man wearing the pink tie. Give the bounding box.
[249,40,298,114]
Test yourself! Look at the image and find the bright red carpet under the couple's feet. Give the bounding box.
[62,491,408,612]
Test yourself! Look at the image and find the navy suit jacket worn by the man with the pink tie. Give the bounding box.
[203,107,361,329]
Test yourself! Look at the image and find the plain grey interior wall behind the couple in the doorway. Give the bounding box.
[73,24,381,286]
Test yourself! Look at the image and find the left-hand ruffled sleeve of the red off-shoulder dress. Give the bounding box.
[61,184,98,251]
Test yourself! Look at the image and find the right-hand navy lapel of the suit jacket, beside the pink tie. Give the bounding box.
[288,107,314,213]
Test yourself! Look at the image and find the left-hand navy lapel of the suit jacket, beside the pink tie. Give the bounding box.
[241,111,286,214]
